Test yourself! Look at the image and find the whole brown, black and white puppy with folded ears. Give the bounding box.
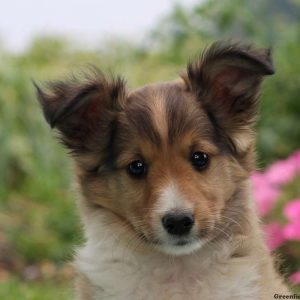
[37,42,288,300]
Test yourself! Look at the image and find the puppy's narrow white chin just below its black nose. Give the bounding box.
[156,240,205,256]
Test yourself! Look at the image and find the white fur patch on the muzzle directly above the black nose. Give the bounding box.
[156,182,192,214]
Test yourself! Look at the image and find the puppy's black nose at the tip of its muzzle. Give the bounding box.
[161,213,195,236]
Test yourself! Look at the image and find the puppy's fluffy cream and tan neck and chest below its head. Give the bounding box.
[76,179,287,300]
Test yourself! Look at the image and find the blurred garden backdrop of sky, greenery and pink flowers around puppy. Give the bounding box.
[0,0,300,300]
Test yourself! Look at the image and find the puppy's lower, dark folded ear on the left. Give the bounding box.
[35,69,126,154]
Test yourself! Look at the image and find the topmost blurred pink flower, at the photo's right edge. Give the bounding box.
[265,156,298,185]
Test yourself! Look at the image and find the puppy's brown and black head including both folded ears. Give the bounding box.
[37,42,274,255]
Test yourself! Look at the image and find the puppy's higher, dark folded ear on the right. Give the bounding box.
[184,42,274,154]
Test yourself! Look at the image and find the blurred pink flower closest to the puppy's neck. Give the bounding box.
[251,172,280,216]
